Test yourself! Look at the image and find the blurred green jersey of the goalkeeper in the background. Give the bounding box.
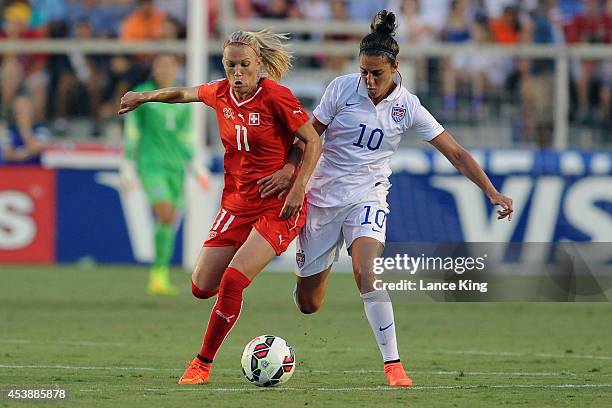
[125,81,195,172]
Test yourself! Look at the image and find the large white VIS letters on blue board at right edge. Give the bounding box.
[430,176,612,242]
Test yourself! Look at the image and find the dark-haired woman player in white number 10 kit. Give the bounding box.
[260,10,513,386]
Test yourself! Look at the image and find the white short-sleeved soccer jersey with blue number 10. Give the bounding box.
[307,73,444,207]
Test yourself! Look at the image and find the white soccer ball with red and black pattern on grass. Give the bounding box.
[242,334,295,387]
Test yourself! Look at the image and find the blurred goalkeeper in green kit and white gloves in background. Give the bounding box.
[121,54,208,295]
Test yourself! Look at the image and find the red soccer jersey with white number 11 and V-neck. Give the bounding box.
[198,78,309,214]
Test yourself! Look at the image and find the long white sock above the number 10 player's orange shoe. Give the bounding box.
[361,290,399,362]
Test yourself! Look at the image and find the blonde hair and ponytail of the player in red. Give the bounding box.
[224,30,293,81]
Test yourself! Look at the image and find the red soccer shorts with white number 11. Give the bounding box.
[204,201,308,255]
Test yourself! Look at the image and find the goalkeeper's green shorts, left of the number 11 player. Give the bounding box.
[138,169,185,208]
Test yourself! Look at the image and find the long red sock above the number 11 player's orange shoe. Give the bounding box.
[200,267,251,361]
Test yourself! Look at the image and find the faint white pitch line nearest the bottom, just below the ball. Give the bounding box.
[139,384,612,392]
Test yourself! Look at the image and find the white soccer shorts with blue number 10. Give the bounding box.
[295,185,389,277]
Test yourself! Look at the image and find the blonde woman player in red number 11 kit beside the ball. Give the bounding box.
[119,30,321,384]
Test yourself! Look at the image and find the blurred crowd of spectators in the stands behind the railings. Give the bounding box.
[0,0,612,145]
